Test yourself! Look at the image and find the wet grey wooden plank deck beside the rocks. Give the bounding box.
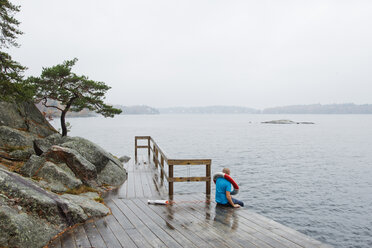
[49,158,330,248]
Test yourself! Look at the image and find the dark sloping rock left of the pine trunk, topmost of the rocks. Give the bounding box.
[0,102,57,137]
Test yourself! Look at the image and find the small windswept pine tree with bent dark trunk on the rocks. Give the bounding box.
[26,58,121,136]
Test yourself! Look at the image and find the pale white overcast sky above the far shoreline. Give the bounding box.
[11,0,372,108]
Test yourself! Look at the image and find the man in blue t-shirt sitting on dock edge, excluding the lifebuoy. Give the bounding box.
[216,168,244,208]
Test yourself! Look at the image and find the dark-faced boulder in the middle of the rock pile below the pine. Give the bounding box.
[43,146,97,183]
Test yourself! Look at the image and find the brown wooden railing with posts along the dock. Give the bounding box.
[134,136,212,196]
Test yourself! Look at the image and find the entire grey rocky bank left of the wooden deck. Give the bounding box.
[0,102,127,247]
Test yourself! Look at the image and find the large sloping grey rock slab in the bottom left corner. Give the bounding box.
[0,168,110,247]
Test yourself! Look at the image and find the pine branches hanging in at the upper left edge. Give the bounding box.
[0,0,28,101]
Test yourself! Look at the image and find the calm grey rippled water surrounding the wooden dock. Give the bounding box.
[53,115,372,247]
